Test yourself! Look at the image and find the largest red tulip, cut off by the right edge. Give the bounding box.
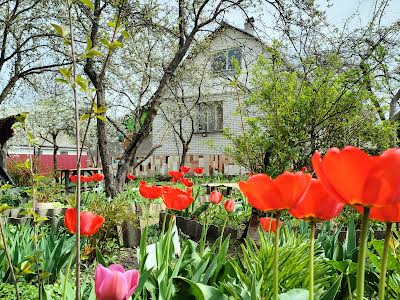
[312,146,400,207]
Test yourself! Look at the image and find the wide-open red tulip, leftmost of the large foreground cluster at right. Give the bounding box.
[239,172,311,211]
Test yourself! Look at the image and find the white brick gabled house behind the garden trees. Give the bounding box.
[135,19,265,176]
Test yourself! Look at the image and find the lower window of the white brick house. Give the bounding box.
[196,101,223,133]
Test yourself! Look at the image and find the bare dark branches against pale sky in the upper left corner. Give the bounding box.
[0,0,68,171]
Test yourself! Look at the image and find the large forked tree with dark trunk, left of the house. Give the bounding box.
[78,0,250,196]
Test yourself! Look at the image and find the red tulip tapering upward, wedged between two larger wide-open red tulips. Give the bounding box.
[289,178,344,222]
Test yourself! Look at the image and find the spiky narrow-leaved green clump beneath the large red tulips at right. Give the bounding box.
[228,231,336,299]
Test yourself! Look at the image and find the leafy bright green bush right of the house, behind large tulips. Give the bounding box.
[226,47,396,175]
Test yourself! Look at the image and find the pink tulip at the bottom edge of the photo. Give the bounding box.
[94,264,139,300]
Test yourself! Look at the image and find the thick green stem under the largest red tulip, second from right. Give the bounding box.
[356,207,370,300]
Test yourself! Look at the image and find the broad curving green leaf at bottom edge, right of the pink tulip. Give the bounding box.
[173,277,227,300]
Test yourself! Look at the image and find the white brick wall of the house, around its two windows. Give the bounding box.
[152,28,263,156]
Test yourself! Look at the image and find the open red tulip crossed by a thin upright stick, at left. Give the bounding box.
[64,208,105,236]
